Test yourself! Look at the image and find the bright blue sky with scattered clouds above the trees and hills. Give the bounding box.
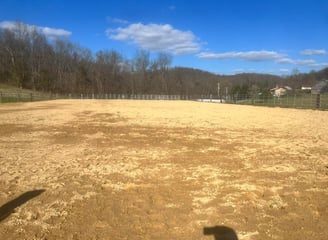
[0,0,328,75]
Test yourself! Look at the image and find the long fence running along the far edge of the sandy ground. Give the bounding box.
[0,92,328,110]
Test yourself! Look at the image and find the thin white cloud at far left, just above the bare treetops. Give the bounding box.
[0,21,72,38]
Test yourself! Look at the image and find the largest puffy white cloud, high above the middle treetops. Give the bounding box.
[106,23,200,55]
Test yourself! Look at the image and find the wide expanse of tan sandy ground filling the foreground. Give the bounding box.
[0,100,328,240]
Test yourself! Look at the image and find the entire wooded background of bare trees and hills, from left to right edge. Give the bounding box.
[0,22,328,95]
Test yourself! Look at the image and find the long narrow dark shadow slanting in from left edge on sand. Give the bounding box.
[0,189,45,222]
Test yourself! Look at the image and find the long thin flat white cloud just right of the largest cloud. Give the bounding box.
[198,50,283,61]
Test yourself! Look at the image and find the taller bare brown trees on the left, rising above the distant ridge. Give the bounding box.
[0,22,172,94]
